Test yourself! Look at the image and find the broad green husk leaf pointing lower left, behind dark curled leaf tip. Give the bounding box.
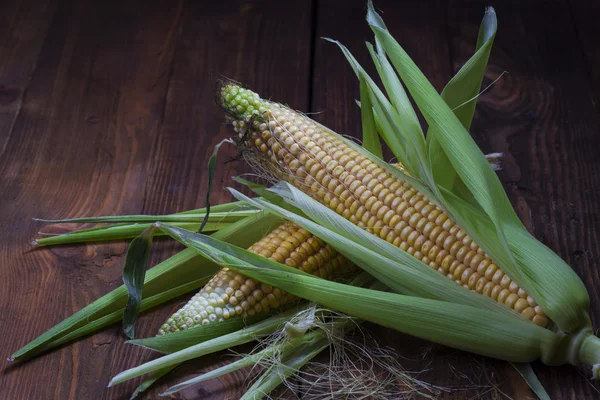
[11,211,282,360]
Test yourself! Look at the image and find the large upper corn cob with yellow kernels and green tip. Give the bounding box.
[221,84,548,327]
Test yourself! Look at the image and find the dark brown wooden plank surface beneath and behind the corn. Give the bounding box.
[0,0,600,399]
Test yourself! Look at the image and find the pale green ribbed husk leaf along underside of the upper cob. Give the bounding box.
[230,182,520,318]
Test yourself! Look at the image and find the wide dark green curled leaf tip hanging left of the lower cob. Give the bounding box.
[123,225,156,339]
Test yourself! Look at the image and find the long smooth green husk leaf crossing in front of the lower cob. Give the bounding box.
[151,224,564,366]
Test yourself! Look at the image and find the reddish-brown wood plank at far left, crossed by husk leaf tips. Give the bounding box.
[0,1,182,399]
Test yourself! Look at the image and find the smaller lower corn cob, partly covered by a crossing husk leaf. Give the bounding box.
[158,222,356,335]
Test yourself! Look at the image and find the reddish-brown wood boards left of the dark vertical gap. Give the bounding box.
[0,1,311,399]
